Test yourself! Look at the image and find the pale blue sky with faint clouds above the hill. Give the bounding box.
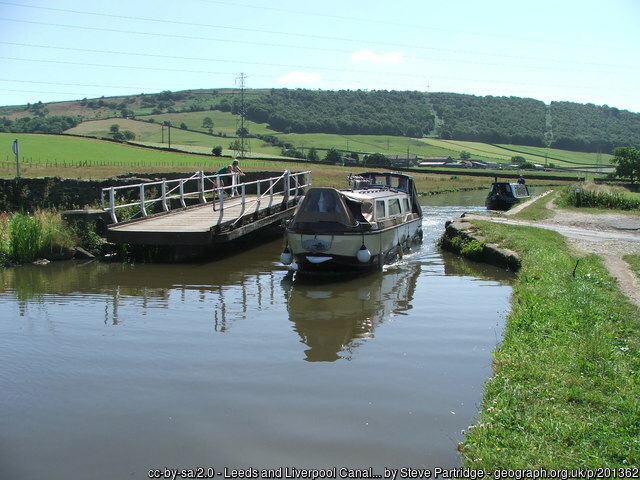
[0,0,640,112]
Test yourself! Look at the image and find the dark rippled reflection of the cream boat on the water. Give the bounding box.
[283,265,420,362]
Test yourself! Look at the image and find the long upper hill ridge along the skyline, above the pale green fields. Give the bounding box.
[0,89,640,153]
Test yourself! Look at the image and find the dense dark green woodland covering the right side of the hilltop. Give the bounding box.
[236,89,640,153]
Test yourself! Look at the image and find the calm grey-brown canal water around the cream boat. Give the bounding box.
[0,189,511,480]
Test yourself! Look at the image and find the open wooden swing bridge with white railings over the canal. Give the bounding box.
[102,170,311,247]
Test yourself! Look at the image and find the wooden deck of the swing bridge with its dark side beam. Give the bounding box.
[106,195,296,245]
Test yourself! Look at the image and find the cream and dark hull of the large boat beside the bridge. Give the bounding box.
[287,218,423,273]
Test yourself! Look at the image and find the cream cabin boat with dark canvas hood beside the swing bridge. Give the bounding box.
[280,172,423,273]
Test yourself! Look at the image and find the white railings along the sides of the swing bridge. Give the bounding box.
[101,170,311,223]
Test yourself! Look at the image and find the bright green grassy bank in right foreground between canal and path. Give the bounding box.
[461,221,640,471]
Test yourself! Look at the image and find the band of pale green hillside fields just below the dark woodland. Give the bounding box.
[61,110,612,168]
